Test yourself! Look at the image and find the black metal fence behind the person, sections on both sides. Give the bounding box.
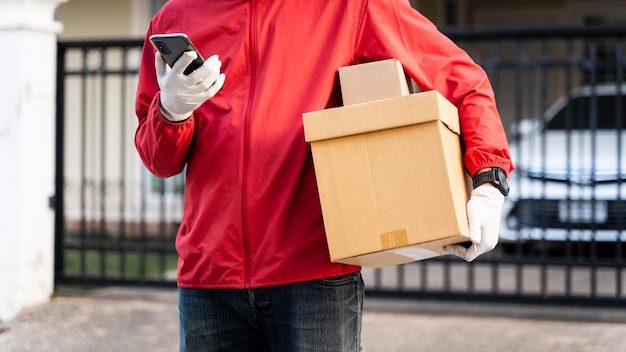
[55,27,626,306]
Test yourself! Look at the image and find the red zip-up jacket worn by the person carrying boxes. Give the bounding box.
[135,0,512,288]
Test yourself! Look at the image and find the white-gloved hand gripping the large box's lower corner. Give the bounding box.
[444,184,504,262]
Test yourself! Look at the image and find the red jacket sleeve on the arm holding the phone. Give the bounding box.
[135,26,194,177]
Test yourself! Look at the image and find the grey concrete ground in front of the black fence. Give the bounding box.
[0,287,626,352]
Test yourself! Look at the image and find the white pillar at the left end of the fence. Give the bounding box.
[0,0,66,321]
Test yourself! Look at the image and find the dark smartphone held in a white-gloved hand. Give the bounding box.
[150,33,204,75]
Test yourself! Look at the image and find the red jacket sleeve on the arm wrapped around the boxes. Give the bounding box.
[354,0,513,176]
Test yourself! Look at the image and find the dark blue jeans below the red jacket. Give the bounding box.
[178,272,364,352]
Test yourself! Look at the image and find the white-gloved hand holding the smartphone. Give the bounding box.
[155,51,226,121]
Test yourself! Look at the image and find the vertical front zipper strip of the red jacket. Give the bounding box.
[241,1,258,288]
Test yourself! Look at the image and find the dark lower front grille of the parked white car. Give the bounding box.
[511,199,626,230]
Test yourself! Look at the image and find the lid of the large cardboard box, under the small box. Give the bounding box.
[302,90,460,142]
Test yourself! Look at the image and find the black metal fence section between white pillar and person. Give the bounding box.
[54,40,182,286]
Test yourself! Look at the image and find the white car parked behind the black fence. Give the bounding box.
[500,84,626,242]
